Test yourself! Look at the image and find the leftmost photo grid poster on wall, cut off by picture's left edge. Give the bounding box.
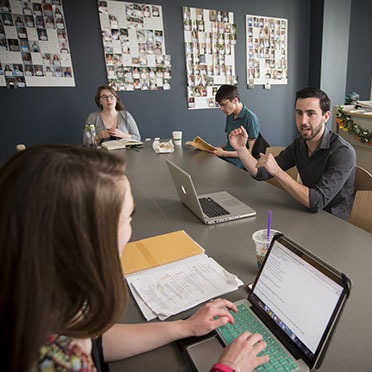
[0,0,75,88]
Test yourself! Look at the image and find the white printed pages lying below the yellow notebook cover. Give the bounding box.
[127,255,243,320]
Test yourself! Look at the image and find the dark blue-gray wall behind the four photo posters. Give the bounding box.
[0,0,371,161]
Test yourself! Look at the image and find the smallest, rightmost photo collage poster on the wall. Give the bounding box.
[246,15,288,89]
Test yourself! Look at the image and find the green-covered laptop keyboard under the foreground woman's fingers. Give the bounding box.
[217,304,298,372]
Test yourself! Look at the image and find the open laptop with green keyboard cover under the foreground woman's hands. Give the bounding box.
[186,234,351,371]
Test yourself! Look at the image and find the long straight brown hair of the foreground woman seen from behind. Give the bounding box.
[0,145,129,371]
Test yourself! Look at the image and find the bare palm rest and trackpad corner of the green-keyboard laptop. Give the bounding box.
[185,336,224,372]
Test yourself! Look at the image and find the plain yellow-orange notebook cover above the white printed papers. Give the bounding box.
[121,230,204,275]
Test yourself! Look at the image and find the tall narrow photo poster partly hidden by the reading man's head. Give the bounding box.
[183,7,237,110]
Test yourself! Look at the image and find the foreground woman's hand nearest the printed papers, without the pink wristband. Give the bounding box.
[185,298,238,336]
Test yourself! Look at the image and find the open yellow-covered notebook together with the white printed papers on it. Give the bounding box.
[122,231,243,320]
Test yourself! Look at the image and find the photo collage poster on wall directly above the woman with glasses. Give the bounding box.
[98,1,171,91]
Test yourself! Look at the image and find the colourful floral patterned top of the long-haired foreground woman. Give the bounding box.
[33,335,96,372]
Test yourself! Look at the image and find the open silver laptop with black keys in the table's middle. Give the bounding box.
[166,160,256,225]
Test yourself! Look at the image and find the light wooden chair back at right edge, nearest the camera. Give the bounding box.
[350,190,372,233]
